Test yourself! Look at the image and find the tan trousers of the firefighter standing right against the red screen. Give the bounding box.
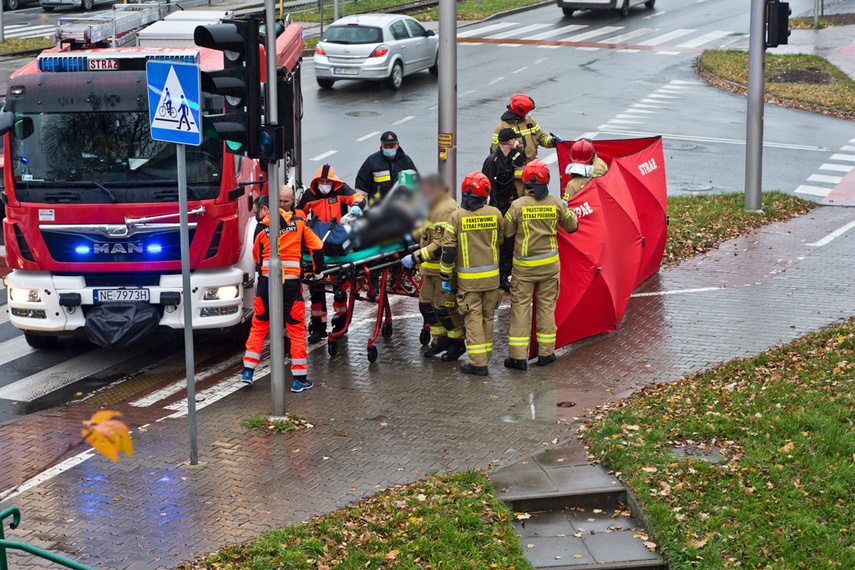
[508,268,559,360]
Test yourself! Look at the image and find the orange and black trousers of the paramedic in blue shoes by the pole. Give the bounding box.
[243,276,308,379]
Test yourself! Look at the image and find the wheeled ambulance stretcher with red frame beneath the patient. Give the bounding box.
[304,240,430,362]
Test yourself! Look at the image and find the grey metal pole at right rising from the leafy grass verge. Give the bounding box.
[745,0,766,210]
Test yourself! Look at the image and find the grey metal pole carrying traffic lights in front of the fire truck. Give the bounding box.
[264,0,285,418]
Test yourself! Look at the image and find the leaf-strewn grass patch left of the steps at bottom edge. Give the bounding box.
[183,471,529,570]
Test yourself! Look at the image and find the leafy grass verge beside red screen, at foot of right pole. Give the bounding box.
[662,192,817,265]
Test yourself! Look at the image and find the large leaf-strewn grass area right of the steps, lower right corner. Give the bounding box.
[587,320,855,570]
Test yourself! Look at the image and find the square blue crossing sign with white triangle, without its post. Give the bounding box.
[145,61,202,146]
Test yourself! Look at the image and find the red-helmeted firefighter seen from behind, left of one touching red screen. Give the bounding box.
[439,172,504,376]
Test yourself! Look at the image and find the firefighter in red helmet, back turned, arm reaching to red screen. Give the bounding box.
[505,160,578,370]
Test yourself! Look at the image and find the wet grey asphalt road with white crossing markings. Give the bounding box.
[0,0,852,423]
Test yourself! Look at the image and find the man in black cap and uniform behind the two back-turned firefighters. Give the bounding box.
[481,128,525,291]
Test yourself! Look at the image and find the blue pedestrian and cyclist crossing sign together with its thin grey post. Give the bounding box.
[146,61,202,465]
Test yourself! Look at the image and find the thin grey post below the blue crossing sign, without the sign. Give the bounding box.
[175,144,199,465]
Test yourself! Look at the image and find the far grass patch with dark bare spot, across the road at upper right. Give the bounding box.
[698,50,855,118]
